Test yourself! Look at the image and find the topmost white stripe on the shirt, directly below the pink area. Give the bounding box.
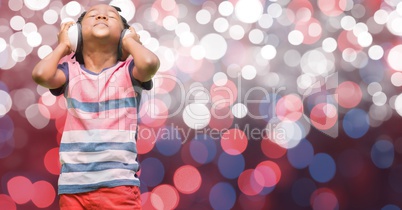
[61,129,136,143]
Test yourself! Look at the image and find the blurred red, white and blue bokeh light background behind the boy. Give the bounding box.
[0,0,402,210]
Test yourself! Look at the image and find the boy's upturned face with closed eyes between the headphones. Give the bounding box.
[81,4,123,43]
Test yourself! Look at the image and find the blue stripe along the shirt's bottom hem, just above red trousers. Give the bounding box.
[58,178,140,195]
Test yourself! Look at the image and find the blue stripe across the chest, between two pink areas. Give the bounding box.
[67,97,137,112]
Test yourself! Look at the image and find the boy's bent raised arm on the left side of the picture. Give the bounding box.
[32,22,74,89]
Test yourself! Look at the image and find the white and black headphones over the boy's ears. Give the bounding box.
[67,7,130,64]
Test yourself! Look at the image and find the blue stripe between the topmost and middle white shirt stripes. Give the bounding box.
[59,142,137,153]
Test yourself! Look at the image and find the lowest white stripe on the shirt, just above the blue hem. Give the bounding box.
[59,169,136,185]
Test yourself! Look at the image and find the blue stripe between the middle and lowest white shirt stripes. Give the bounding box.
[61,161,138,173]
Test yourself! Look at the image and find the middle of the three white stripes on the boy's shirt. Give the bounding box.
[60,150,137,164]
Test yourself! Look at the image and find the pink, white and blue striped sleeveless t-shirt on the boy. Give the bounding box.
[50,58,152,194]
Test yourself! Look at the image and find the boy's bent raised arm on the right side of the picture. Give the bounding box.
[123,27,160,82]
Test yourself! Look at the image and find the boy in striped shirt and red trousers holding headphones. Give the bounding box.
[32,4,159,210]
